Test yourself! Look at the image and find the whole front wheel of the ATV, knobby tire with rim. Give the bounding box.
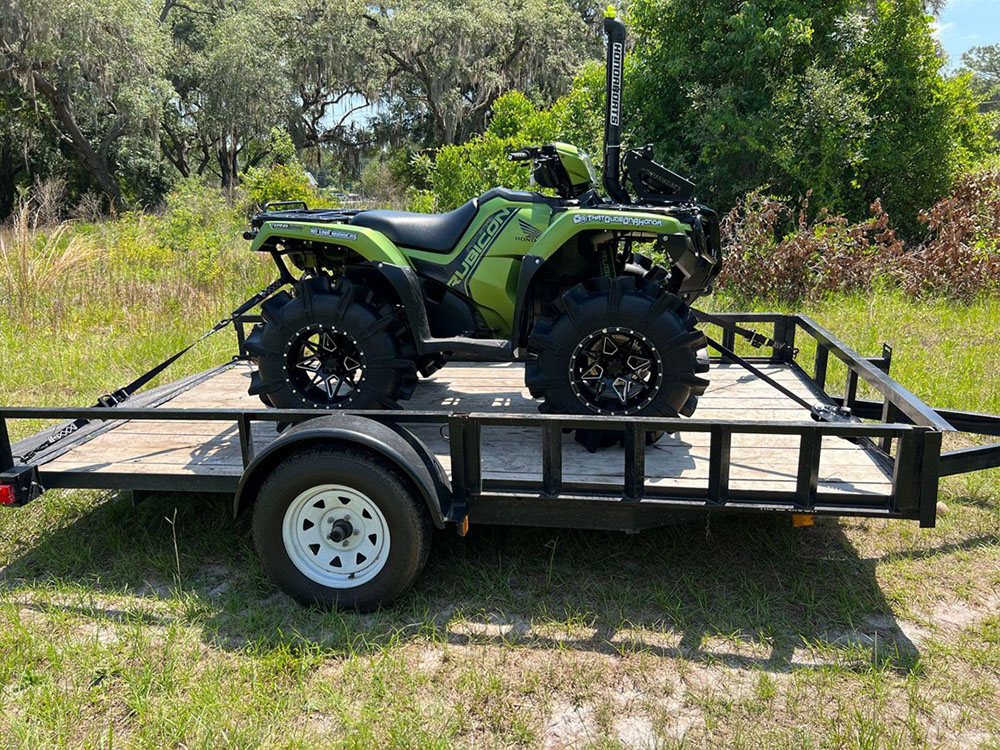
[525,276,709,417]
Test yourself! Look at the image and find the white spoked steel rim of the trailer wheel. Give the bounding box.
[281,484,390,589]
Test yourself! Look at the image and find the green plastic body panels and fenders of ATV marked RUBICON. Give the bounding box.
[251,198,687,351]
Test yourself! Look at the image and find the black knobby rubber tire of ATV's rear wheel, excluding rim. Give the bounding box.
[246,277,417,409]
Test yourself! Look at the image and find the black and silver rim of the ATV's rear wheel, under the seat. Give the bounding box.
[287,326,366,409]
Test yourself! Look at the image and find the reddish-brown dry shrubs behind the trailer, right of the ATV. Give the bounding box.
[719,171,1000,301]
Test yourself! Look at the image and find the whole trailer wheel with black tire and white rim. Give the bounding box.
[253,446,431,612]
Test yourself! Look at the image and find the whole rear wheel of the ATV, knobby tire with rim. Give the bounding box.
[246,277,417,409]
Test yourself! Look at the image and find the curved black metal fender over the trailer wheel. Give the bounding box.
[233,414,452,529]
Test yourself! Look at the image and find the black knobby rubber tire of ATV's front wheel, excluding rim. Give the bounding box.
[525,275,709,417]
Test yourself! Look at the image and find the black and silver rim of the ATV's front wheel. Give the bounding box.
[569,328,663,414]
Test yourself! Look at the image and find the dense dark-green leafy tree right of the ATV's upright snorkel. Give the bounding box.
[626,0,990,230]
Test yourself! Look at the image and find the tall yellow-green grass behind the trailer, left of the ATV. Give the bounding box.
[0,186,274,438]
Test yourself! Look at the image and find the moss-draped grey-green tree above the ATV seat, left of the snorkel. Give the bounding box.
[367,0,596,143]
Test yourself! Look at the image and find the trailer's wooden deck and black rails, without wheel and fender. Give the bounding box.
[0,313,1000,531]
